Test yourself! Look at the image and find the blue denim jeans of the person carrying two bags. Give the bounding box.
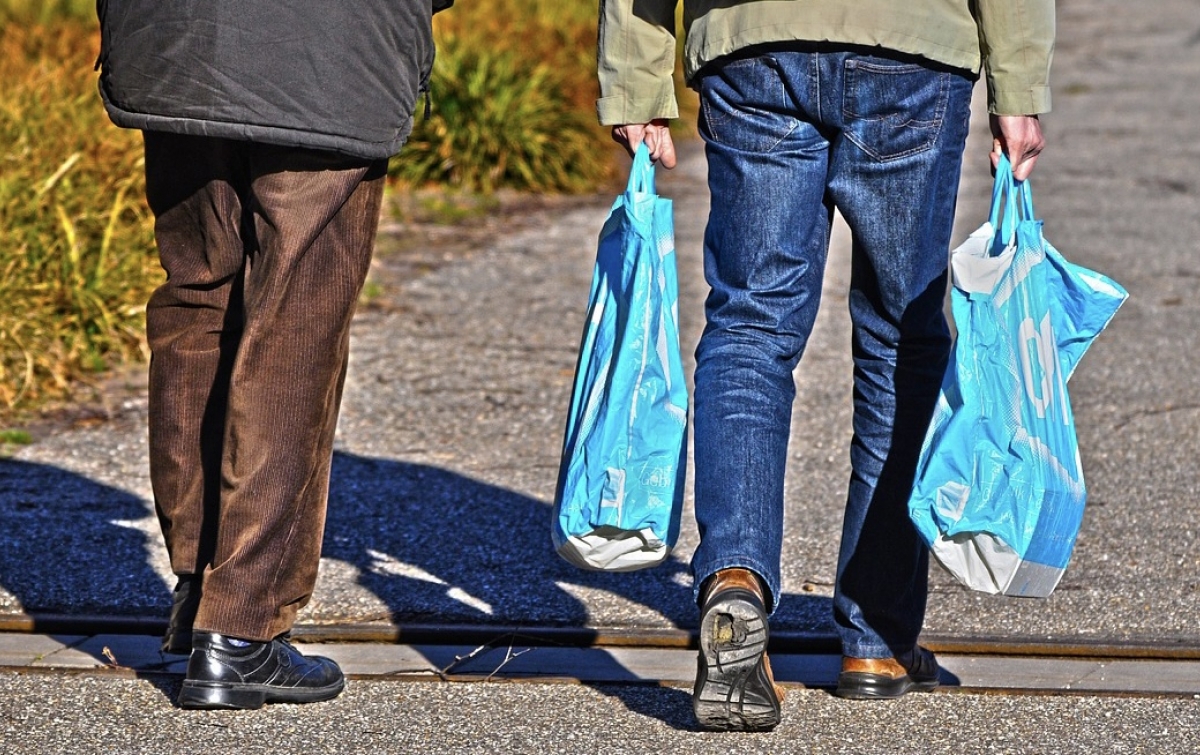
[692,47,973,658]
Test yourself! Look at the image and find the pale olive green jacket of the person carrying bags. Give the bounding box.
[596,0,1055,125]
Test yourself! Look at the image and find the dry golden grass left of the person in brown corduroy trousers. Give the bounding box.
[0,22,162,413]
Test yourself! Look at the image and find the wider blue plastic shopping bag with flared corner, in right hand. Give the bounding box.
[908,158,1127,598]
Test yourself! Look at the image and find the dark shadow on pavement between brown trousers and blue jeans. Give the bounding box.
[323,453,695,629]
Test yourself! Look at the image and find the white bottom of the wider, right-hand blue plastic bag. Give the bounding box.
[930,533,1064,598]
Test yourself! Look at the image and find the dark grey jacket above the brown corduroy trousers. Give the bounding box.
[97,0,449,158]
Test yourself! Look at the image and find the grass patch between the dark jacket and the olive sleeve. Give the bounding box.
[390,0,614,193]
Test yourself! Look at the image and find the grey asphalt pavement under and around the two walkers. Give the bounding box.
[0,0,1200,755]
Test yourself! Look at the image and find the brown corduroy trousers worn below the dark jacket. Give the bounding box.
[144,132,386,641]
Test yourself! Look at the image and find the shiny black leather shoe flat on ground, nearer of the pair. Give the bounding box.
[179,631,346,711]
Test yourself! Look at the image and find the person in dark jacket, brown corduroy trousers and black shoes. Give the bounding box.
[96,0,454,709]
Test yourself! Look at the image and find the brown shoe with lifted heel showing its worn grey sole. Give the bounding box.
[691,569,784,731]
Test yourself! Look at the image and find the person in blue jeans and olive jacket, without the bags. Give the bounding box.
[598,0,1054,730]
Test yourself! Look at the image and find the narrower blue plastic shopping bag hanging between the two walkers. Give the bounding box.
[553,144,688,571]
